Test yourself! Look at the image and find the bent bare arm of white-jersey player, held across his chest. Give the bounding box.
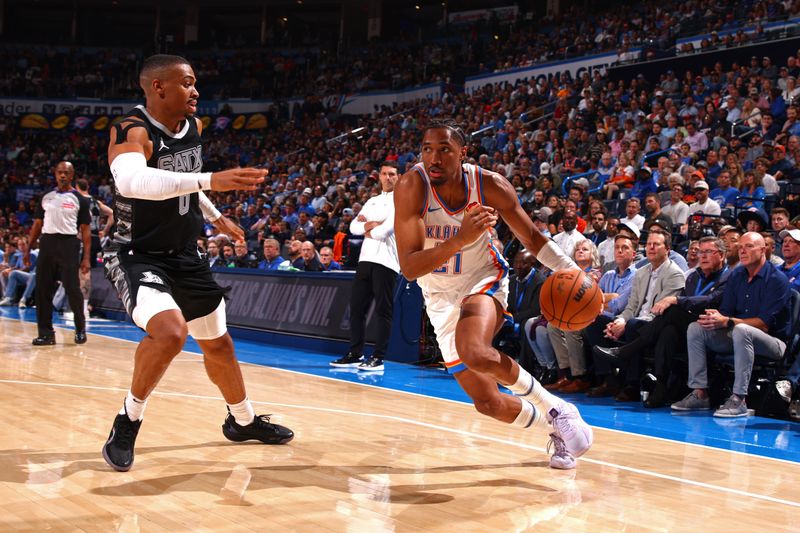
[394,172,497,281]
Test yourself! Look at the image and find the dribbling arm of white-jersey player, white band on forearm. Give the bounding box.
[483,170,578,271]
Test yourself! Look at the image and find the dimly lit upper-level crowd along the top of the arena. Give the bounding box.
[0,0,800,100]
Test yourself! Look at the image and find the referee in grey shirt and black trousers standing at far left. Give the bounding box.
[29,161,92,346]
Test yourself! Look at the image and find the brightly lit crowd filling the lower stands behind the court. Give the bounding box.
[0,34,800,412]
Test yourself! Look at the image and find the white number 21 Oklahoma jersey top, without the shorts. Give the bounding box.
[414,163,508,295]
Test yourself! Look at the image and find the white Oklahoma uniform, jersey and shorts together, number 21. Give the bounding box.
[414,163,508,373]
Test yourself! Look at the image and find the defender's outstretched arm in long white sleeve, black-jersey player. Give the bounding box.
[108,122,267,200]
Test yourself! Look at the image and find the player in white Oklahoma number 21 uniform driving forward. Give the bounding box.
[394,120,592,469]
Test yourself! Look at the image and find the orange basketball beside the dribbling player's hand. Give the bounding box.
[539,270,603,331]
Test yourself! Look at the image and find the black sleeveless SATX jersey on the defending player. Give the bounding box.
[112,105,203,255]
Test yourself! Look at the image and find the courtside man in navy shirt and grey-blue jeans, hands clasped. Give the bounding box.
[672,232,789,418]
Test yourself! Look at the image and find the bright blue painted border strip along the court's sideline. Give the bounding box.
[6,307,800,463]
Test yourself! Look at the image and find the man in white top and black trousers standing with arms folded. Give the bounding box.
[331,161,400,371]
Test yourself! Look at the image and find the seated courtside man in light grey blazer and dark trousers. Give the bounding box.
[586,228,686,401]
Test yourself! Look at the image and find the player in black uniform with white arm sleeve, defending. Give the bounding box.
[103,55,294,471]
